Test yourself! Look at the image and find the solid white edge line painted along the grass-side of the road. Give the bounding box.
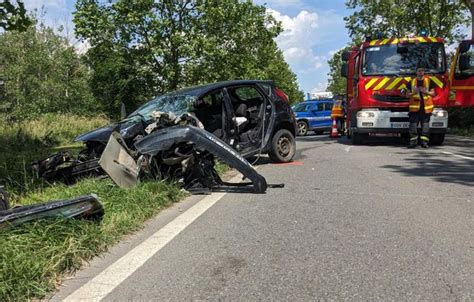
[64,175,242,301]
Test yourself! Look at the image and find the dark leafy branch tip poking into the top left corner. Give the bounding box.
[0,0,33,31]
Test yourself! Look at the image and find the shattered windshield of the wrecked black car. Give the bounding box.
[128,95,196,120]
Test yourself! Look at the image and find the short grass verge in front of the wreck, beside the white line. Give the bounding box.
[0,179,185,301]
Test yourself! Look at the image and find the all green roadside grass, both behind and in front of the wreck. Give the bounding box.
[0,115,188,301]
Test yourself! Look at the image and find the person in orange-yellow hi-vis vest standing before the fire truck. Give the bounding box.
[408,68,436,148]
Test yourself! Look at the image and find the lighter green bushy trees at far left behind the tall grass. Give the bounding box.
[0,20,97,118]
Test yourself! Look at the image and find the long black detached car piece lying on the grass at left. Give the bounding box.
[0,194,104,230]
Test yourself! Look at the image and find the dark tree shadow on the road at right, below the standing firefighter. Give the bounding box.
[382,153,474,187]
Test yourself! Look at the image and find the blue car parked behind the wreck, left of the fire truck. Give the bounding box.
[292,100,334,135]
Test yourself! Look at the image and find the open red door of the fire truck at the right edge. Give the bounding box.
[449,40,474,107]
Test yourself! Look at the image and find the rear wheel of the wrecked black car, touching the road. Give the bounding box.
[268,129,296,163]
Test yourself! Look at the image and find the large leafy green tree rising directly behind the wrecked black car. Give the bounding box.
[74,0,304,113]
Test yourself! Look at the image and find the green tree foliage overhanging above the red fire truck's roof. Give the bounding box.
[344,0,471,43]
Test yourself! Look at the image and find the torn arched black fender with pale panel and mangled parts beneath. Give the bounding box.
[99,125,267,193]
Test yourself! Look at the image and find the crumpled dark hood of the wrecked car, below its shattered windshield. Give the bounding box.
[74,120,143,144]
